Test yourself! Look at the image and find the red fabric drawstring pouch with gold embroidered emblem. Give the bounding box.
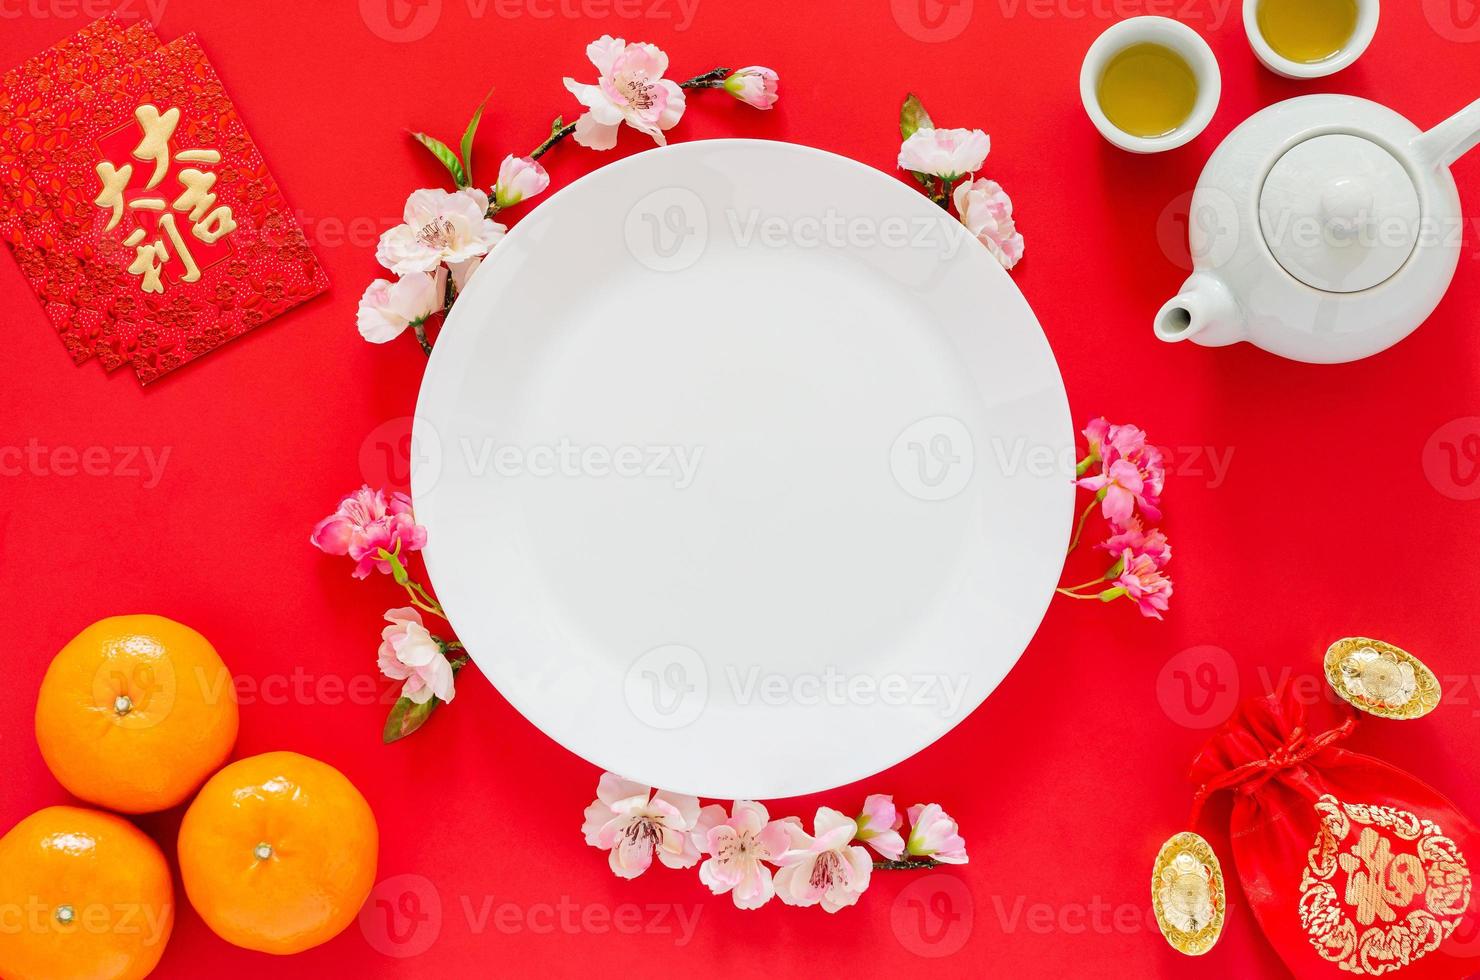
[1191,693,1480,980]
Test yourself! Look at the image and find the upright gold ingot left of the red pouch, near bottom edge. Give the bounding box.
[1151,830,1227,956]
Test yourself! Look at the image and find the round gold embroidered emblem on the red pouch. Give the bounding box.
[1299,795,1470,977]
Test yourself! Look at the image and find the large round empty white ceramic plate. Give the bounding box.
[411,139,1073,799]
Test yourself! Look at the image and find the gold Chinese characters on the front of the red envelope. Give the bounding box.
[93,105,237,293]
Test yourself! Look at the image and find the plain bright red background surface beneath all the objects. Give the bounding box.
[0,0,1480,979]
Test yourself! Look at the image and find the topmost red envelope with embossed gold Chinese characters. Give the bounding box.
[7,36,329,383]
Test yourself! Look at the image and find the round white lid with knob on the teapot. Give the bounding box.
[1259,133,1422,293]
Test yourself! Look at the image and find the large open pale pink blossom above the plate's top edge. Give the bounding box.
[565,34,685,150]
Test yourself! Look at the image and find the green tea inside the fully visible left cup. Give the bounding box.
[1097,41,1197,139]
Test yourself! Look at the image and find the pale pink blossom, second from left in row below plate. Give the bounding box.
[694,799,792,909]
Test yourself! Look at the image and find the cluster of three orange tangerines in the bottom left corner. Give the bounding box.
[0,616,377,980]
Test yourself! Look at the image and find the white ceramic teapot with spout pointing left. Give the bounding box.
[1156,95,1480,364]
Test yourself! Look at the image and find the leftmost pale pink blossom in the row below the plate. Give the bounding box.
[582,773,699,878]
